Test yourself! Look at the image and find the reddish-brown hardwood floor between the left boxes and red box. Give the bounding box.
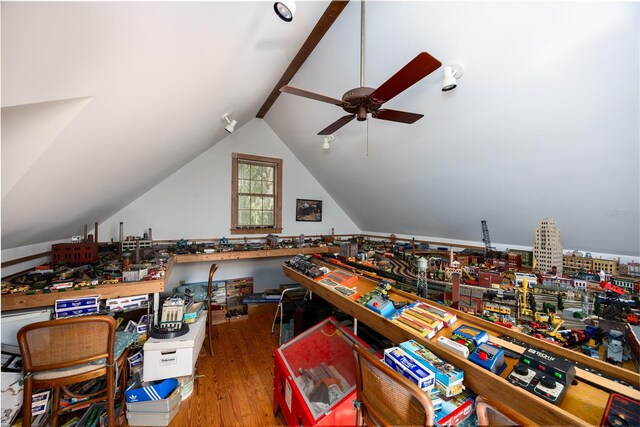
[164,314,285,427]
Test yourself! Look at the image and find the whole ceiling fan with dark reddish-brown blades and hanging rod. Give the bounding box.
[280,0,442,135]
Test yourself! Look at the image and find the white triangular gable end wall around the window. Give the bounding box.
[99,119,360,289]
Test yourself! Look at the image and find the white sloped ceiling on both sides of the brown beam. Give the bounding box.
[2,1,640,256]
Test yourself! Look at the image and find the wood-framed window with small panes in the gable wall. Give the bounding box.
[231,153,282,234]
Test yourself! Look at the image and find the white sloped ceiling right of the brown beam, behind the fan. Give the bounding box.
[266,1,640,257]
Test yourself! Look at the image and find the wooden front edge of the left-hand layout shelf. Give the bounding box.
[2,279,164,312]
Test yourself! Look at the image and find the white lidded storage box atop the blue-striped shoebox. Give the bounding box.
[142,311,207,382]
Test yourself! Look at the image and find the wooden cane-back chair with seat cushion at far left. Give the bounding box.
[18,316,128,427]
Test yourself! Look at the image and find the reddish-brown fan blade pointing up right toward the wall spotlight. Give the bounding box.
[370,52,442,104]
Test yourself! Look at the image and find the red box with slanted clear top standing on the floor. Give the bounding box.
[273,317,369,426]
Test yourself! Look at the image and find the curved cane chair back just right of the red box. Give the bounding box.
[353,345,434,427]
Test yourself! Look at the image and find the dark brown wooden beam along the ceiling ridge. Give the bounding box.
[256,0,349,119]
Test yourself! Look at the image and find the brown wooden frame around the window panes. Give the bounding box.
[230,153,282,234]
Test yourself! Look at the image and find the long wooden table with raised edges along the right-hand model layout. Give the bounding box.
[283,264,640,425]
